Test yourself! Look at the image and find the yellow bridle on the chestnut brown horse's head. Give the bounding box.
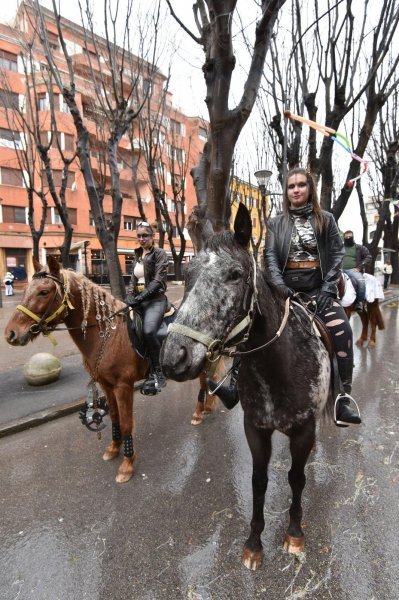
[17,271,74,345]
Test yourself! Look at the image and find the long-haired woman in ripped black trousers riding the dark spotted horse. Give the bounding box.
[209,167,361,427]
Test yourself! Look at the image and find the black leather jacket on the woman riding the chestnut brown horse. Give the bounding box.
[127,246,168,300]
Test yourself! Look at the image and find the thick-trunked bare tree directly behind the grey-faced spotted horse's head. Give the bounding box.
[167,0,285,249]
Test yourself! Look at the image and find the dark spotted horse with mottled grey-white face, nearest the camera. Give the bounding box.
[161,204,333,570]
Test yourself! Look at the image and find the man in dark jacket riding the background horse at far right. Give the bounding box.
[342,230,371,311]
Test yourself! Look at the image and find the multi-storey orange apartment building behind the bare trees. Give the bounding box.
[0,0,207,282]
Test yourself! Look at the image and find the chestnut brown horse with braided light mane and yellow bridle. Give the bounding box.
[5,257,215,483]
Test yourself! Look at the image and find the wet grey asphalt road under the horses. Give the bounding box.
[0,305,399,600]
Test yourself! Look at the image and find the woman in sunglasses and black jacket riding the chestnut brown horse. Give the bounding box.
[126,221,168,395]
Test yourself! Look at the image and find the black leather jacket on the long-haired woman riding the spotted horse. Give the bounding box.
[264,211,344,296]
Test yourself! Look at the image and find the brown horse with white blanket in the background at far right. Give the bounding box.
[341,273,385,348]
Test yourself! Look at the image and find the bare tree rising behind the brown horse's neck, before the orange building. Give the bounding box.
[34,0,159,297]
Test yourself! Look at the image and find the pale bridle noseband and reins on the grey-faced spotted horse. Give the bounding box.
[168,256,290,362]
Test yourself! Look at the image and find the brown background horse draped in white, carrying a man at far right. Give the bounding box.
[342,274,385,348]
